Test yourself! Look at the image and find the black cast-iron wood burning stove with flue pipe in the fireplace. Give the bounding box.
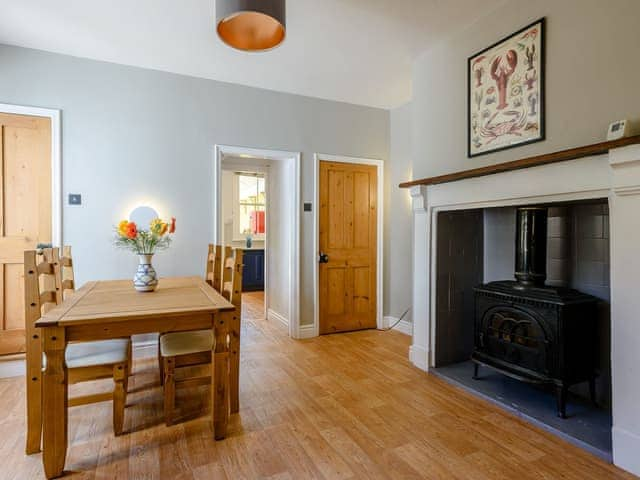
[471,207,598,418]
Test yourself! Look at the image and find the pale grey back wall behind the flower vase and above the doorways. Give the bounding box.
[0,46,389,324]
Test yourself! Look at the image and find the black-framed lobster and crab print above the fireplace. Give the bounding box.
[467,18,545,157]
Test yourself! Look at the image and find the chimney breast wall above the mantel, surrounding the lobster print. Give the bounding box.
[412,0,640,178]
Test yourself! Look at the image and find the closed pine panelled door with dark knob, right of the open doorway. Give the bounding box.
[318,161,378,334]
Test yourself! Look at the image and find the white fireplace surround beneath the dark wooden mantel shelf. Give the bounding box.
[409,145,640,475]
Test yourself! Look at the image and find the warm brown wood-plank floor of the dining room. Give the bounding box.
[0,288,633,480]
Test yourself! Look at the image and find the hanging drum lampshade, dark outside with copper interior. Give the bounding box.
[216,0,285,52]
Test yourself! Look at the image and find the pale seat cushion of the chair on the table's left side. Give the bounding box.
[42,338,130,368]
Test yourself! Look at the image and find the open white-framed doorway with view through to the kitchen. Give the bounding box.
[214,145,300,338]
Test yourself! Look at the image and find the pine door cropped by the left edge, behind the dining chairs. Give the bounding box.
[0,113,52,355]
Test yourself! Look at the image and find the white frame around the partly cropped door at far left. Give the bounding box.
[0,103,62,247]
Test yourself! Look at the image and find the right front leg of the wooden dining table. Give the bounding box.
[211,312,233,440]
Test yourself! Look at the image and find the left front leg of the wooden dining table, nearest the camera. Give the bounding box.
[42,327,68,478]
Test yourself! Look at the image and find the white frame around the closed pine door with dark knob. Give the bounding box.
[313,153,384,337]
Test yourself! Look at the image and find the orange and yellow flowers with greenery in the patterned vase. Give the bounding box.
[114,217,176,255]
